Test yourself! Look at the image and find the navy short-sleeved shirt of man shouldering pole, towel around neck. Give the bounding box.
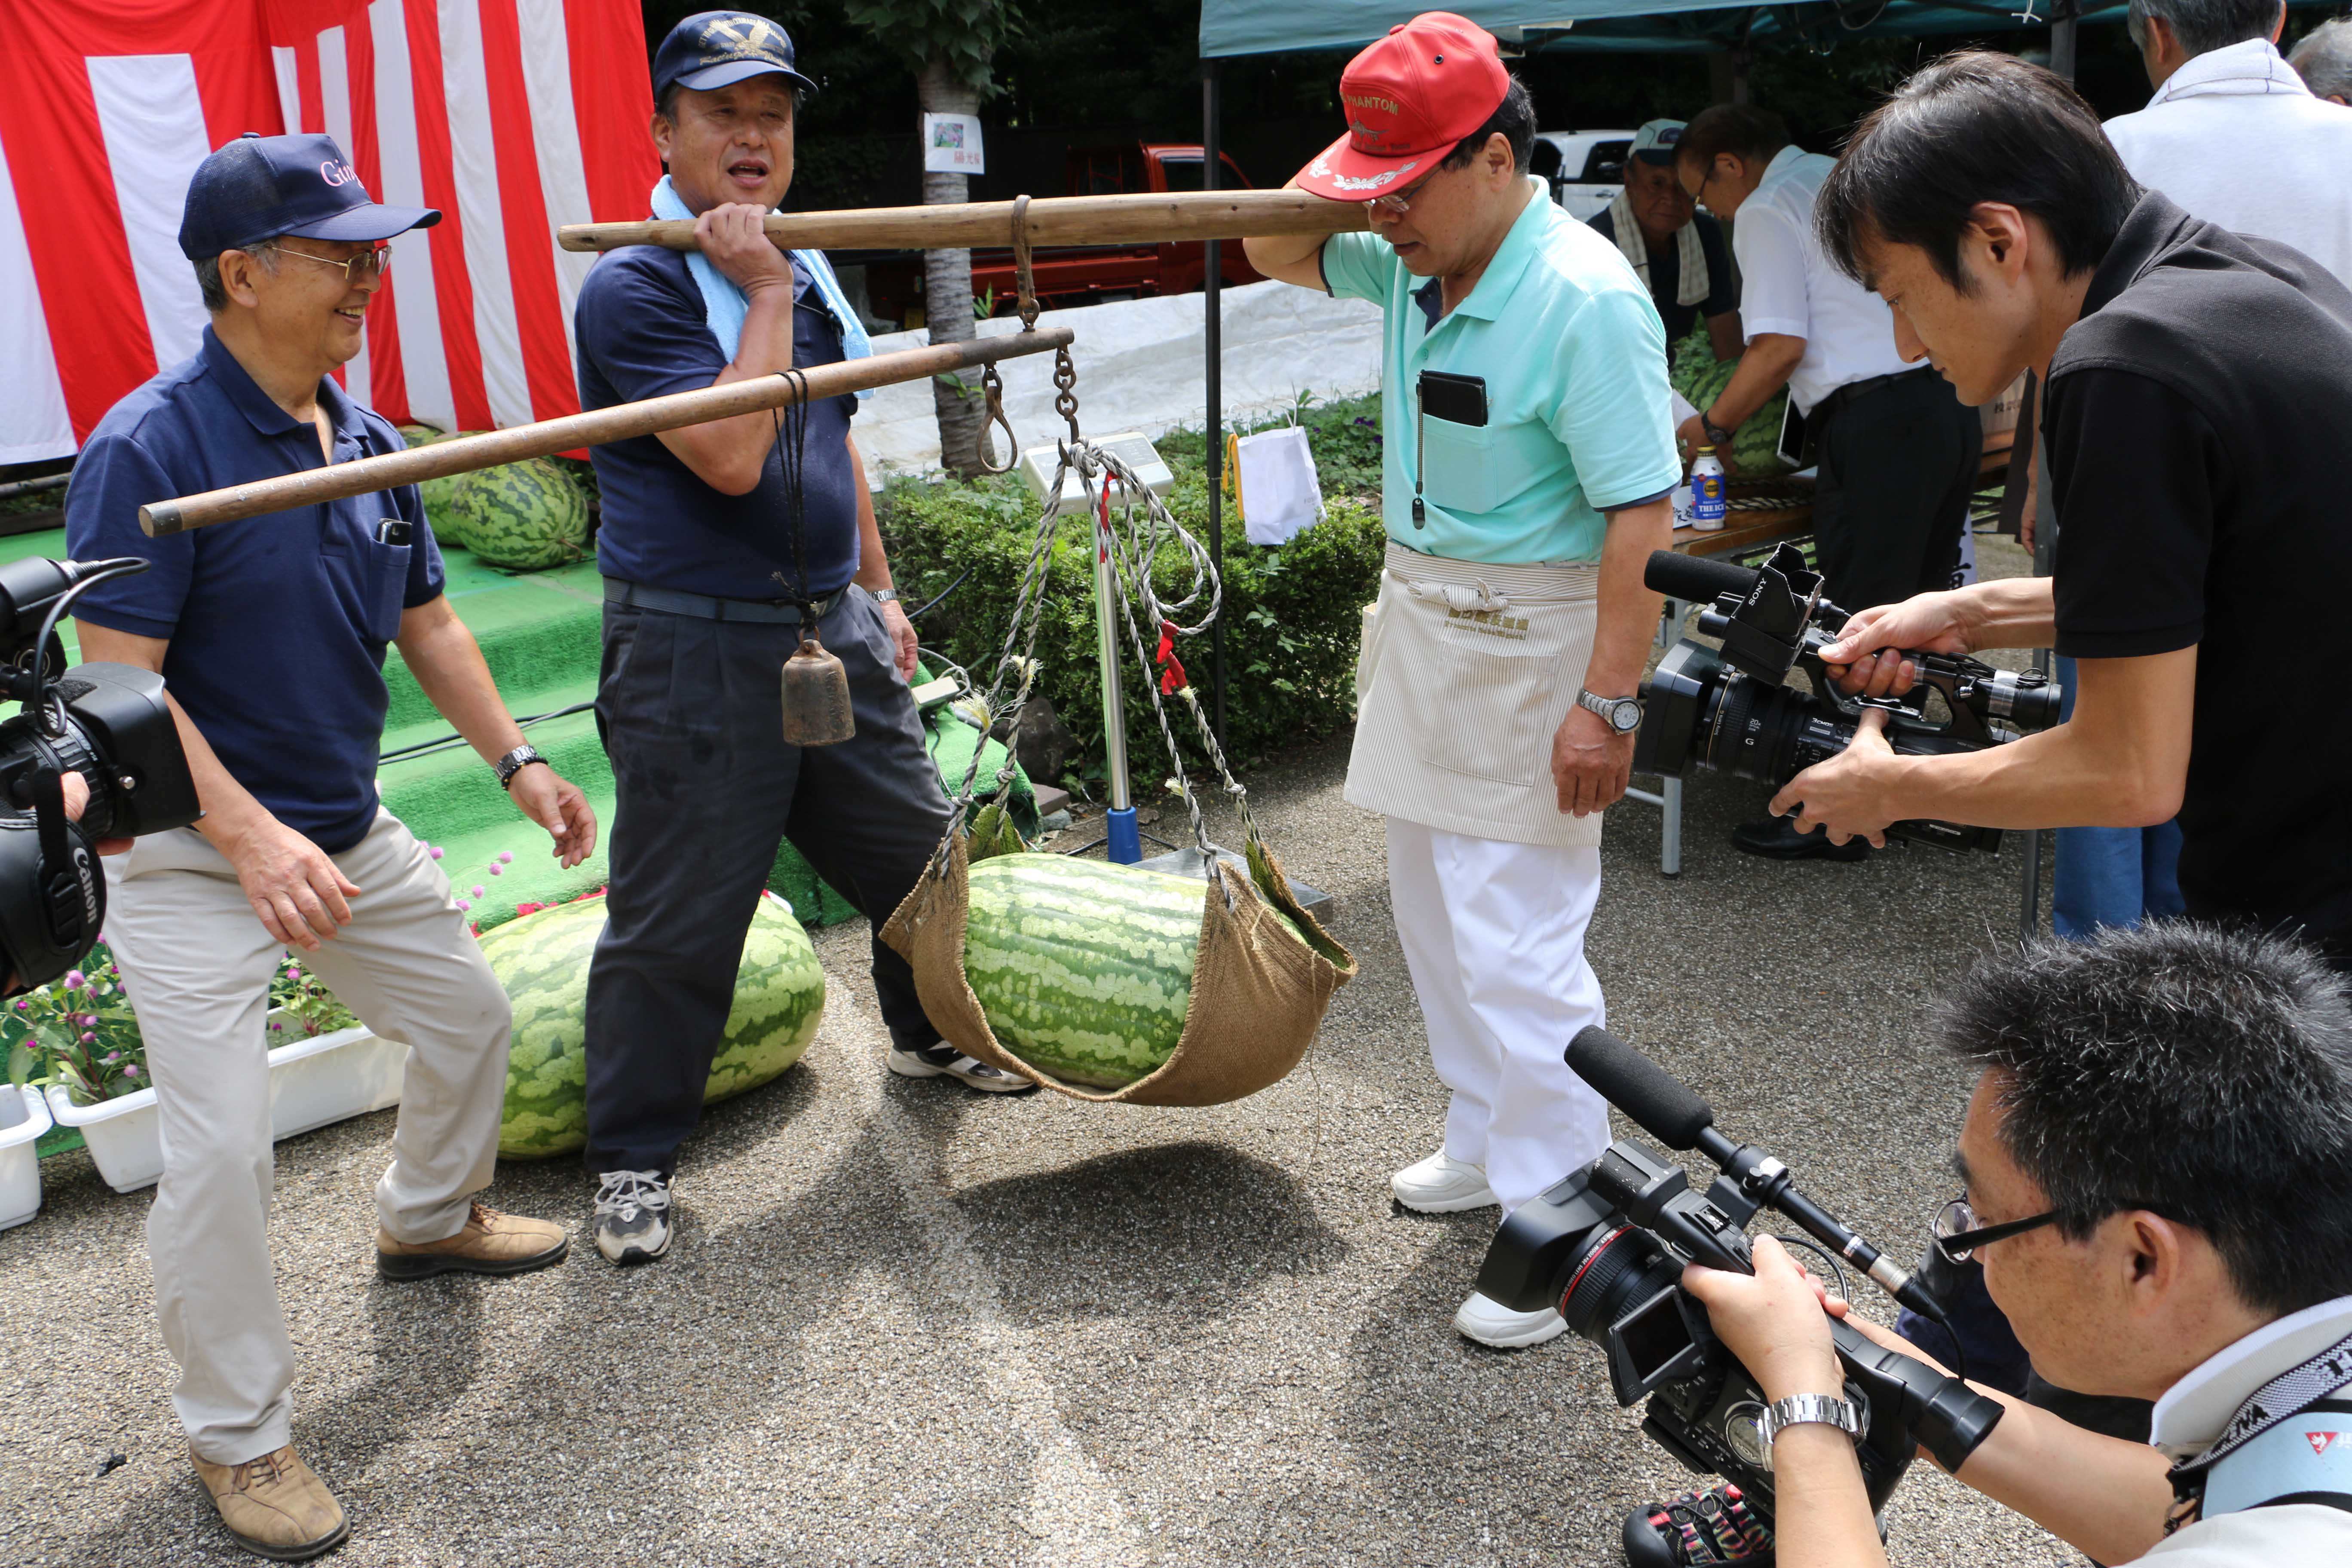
[572,245,858,600]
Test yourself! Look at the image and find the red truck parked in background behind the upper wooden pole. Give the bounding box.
[866,141,1263,327]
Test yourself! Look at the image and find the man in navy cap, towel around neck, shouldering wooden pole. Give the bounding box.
[574,12,1028,1262]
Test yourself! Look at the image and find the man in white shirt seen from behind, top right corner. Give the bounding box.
[2105,0,2352,287]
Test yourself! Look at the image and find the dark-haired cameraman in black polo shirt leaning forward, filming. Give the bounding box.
[1773,54,2352,966]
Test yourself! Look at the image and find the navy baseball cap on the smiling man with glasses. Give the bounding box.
[179,132,440,261]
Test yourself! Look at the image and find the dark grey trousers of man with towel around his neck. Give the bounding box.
[586,588,948,1173]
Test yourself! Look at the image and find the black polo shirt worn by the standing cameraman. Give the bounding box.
[2042,190,2352,955]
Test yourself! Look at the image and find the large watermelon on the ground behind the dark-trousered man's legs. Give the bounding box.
[482,893,826,1159]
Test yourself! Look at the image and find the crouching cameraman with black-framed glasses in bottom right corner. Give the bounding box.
[1684,924,2352,1568]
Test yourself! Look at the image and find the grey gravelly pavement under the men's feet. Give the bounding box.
[0,543,2079,1568]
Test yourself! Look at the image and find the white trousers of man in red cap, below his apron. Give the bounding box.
[1387,816,1609,1213]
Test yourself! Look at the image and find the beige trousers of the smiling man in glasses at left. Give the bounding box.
[106,811,513,1464]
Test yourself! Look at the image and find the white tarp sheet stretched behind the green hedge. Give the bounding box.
[851,282,1381,484]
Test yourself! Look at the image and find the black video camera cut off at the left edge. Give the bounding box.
[0,555,202,987]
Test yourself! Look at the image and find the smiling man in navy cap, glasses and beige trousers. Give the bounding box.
[66,136,595,1561]
